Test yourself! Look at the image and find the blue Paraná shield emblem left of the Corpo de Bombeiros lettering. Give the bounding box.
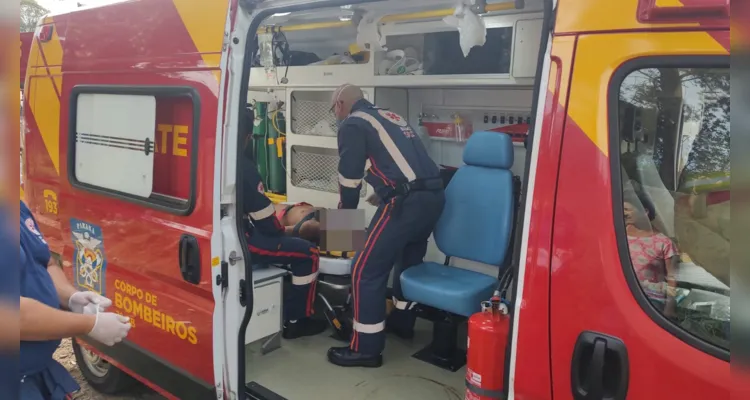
[70,219,107,296]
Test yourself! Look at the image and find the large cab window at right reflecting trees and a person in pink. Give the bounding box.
[610,57,731,354]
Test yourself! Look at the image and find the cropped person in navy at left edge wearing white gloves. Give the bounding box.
[18,202,130,400]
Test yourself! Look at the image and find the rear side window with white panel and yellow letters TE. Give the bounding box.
[68,86,198,214]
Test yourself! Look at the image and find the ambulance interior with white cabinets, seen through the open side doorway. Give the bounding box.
[245,0,544,399]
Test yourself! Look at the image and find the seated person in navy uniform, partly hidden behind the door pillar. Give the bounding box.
[242,125,327,339]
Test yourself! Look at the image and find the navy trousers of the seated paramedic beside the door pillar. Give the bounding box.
[247,230,320,321]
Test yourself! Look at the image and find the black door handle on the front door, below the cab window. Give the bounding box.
[570,331,629,400]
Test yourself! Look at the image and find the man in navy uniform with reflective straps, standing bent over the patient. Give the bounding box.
[328,84,445,367]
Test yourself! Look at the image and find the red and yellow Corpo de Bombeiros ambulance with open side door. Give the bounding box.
[22,0,730,400]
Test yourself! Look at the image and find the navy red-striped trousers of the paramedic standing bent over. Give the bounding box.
[349,190,445,355]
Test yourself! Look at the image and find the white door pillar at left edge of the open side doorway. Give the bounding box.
[223,0,378,400]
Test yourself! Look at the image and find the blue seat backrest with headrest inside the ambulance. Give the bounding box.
[434,132,513,267]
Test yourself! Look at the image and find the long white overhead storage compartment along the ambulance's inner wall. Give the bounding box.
[250,9,542,87]
